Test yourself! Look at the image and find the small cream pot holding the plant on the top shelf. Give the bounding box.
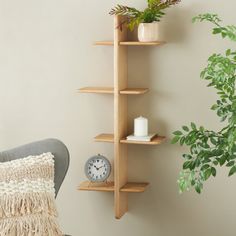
[138,22,158,42]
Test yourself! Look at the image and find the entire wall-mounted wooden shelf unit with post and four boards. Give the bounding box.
[79,16,165,219]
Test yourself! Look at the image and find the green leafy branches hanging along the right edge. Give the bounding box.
[172,14,236,193]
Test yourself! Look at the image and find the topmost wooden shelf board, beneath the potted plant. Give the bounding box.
[94,41,166,46]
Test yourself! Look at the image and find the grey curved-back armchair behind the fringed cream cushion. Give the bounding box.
[0,139,70,236]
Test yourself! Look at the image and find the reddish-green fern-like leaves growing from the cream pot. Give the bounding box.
[109,0,181,31]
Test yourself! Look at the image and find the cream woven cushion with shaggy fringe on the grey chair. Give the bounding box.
[0,153,62,236]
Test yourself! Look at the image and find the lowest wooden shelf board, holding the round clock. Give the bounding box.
[78,181,149,193]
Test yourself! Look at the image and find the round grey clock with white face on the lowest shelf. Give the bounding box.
[85,155,111,182]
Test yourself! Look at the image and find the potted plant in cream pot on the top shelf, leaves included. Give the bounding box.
[110,0,180,42]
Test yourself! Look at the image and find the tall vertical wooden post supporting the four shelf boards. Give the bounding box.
[114,16,128,219]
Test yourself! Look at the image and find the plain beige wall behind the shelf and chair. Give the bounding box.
[0,0,236,236]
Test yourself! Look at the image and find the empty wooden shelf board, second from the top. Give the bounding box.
[78,87,149,95]
